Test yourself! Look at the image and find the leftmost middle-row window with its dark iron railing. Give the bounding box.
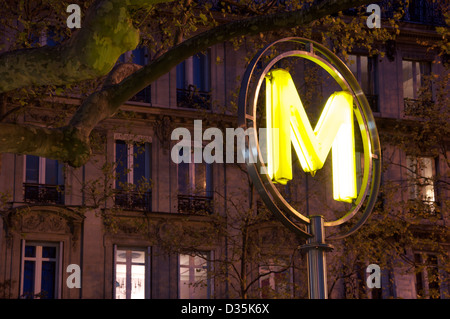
[24,155,64,204]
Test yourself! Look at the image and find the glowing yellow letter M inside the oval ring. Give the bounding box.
[266,69,357,202]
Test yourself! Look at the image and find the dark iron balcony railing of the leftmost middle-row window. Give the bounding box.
[23,183,64,205]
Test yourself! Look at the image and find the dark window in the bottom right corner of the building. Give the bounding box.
[414,253,440,299]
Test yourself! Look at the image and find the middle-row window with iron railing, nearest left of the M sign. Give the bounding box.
[177,148,213,214]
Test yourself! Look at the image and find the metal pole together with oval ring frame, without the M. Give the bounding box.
[238,37,381,299]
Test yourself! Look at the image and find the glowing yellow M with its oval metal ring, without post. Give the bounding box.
[238,38,381,238]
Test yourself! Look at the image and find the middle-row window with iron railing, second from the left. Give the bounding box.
[115,140,151,211]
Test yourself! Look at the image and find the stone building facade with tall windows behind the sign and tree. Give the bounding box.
[0,1,450,299]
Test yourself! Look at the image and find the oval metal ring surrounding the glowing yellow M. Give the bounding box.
[238,37,381,239]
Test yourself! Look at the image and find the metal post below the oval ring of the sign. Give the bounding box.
[300,216,333,299]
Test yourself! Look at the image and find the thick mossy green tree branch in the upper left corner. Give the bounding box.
[0,0,170,93]
